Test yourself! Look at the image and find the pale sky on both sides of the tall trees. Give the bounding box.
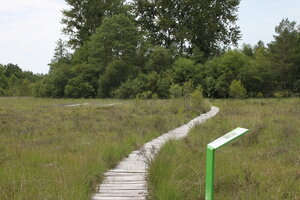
[0,0,300,74]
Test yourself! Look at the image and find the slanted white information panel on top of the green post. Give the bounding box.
[207,128,249,149]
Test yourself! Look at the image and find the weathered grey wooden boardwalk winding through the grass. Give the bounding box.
[92,107,219,200]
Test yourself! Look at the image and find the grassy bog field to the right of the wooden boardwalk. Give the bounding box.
[149,98,300,200]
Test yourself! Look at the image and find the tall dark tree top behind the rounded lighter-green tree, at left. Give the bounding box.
[62,0,125,48]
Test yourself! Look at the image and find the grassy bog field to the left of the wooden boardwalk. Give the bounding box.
[0,98,208,200]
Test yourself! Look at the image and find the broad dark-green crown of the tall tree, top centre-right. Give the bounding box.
[133,0,240,56]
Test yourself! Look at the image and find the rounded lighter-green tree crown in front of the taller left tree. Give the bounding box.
[88,15,138,74]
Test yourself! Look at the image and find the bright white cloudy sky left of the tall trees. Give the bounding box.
[0,0,66,73]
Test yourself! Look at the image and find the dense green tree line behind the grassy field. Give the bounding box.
[0,0,300,98]
